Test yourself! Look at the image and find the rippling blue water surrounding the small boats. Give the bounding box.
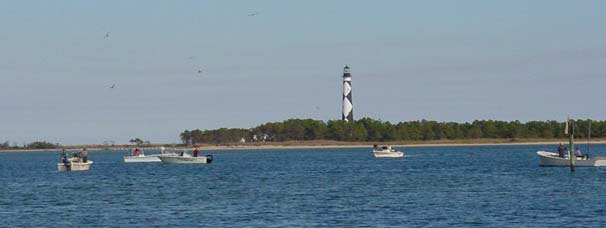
[0,145,606,227]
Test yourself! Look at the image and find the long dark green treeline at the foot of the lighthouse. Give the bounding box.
[180,118,606,144]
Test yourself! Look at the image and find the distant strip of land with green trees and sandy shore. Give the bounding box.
[0,118,606,151]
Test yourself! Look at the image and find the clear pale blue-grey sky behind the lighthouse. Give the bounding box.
[0,0,606,144]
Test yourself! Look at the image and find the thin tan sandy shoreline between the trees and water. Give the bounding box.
[0,139,606,153]
